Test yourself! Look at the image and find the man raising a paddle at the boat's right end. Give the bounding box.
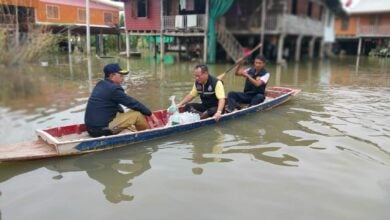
[226,55,269,112]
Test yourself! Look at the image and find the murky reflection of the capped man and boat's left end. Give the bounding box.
[0,146,157,203]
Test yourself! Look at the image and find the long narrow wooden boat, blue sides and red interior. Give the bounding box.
[0,87,300,161]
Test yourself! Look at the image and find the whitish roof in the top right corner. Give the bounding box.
[347,0,390,14]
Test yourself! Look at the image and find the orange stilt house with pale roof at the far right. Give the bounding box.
[334,0,390,57]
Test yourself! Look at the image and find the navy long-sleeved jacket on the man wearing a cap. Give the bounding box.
[84,79,152,128]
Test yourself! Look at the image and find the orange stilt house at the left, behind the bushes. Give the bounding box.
[0,0,123,53]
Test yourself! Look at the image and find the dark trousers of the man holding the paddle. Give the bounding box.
[228,92,265,111]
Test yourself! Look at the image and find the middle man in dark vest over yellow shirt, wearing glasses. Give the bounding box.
[177,64,225,121]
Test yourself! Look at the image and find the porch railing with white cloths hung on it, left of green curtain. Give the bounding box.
[163,14,206,31]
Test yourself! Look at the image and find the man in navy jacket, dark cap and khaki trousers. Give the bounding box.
[84,64,159,137]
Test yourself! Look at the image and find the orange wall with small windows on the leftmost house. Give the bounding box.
[36,2,119,26]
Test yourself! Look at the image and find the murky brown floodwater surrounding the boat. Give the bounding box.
[0,56,390,220]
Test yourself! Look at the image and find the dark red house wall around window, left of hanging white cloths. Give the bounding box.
[125,0,161,31]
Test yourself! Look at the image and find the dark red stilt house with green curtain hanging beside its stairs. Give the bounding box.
[121,0,342,63]
